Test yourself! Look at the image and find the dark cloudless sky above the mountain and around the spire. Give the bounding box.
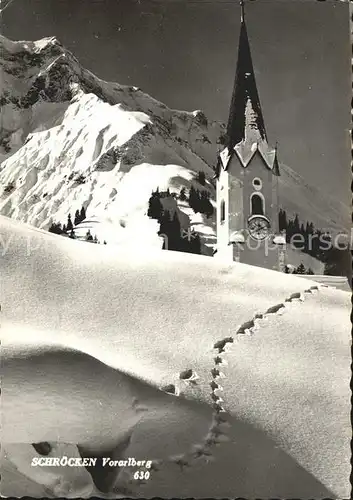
[2,0,350,203]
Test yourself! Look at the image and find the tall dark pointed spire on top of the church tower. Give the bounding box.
[227,0,267,148]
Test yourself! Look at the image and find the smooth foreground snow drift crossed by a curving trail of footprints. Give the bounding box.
[0,217,351,498]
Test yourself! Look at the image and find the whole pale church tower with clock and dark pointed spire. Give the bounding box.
[215,0,285,271]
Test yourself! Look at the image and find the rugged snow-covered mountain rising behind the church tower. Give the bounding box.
[0,33,349,247]
